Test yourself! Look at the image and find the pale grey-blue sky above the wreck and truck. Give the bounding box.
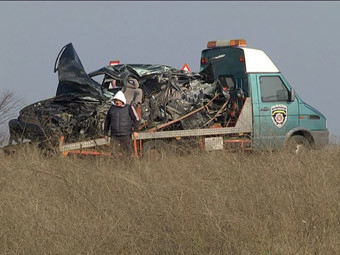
[0,1,340,139]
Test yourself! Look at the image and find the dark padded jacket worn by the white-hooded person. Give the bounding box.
[104,104,139,136]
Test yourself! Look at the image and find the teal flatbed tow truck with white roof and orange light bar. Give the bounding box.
[59,39,329,156]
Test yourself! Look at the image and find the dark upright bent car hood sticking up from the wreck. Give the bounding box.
[54,43,103,99]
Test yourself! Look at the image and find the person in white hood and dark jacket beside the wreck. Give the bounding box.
[104,91,140,154]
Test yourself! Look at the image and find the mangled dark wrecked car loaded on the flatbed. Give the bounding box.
[9,43,236,145]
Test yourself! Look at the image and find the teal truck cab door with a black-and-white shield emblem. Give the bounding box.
[257,74,299,148]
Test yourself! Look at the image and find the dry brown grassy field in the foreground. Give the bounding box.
[0,146,340,254]
